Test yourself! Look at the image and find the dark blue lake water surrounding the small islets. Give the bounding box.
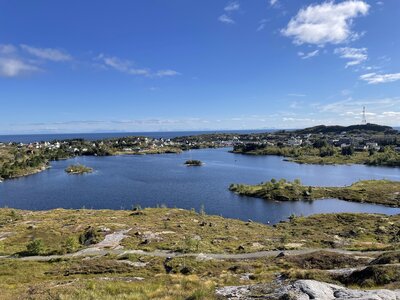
[0,149,400,223]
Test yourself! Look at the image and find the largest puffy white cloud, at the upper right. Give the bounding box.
[281,0,370,46]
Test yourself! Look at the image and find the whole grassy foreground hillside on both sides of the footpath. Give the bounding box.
[0,208,400,299]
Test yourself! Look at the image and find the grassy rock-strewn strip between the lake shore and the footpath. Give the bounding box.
[0,208,400,255]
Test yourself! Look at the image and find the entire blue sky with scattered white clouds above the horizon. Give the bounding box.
[0,0,400,134]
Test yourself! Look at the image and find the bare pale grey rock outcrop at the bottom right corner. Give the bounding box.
[216,280,400,300]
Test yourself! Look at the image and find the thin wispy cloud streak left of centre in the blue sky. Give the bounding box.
[96,54,180,77]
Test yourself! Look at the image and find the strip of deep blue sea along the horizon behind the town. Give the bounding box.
[0,129,274,143]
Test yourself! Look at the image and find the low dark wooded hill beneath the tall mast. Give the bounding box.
[295,123,397,134]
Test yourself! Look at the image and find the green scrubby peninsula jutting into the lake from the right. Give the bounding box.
[229,179,400,207]
